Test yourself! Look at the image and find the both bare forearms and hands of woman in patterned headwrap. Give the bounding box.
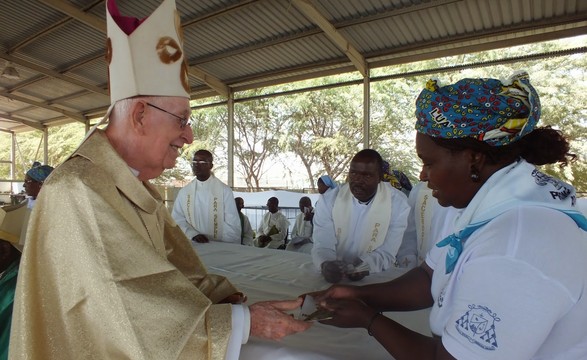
[315,264,454,360]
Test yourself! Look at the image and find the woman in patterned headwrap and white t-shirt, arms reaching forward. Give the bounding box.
[310,73,587,360]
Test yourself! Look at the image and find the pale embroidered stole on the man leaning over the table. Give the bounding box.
[332,183,392,253]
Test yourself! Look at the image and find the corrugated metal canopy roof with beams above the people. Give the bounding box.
[0,0,587,133]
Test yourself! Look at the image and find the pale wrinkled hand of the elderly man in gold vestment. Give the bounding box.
[249,298,312,340]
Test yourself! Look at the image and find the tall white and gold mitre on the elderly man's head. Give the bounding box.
[106,0,189,104]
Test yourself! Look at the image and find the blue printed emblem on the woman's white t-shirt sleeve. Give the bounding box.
[456,304,500,350]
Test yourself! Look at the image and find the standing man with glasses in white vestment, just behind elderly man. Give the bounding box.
[171,150,241,244]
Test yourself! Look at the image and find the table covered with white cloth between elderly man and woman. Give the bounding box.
[194,242,430,360]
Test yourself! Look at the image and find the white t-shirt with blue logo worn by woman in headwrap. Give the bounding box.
[426,207,587,360]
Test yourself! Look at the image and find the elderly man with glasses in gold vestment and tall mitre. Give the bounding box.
[9,0,309,360]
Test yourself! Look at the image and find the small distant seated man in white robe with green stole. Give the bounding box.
[254,197,289,249]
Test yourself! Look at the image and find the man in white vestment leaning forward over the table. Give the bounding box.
[312,149,410,282]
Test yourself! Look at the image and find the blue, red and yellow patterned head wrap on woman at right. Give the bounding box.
[416,72,540,146]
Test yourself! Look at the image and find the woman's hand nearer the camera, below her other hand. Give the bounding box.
[320,299,377,328]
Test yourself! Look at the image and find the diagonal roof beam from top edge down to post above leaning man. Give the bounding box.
[293,0,369,77]
